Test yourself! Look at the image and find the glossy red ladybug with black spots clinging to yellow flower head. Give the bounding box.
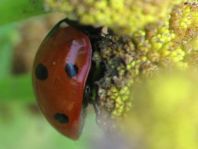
[32,19,102,140]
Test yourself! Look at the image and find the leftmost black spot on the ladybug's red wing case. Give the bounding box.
[35,64,48,80]
